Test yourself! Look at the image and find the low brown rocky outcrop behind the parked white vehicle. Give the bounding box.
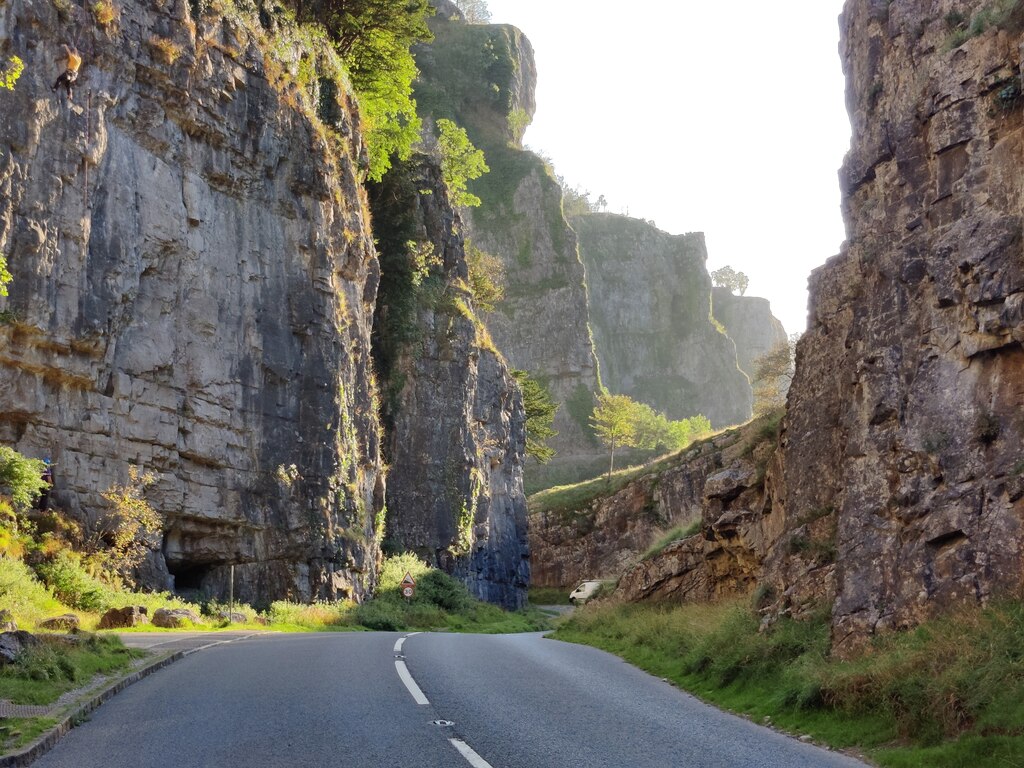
[529,421,774,600]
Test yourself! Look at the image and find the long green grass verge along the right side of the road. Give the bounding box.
[554,601,1024,768]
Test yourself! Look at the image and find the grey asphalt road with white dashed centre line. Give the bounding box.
[35,633,862,768]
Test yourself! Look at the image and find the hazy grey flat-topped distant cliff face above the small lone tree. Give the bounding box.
[572,213,754,427]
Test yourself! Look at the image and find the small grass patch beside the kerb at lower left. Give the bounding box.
[0,635,145,705]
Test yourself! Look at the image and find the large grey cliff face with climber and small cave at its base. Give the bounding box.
[0,0,383,603]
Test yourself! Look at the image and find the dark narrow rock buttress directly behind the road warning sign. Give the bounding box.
[373,156,529,608]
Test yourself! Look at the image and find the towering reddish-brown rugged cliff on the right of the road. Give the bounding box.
[766,0,1024,653]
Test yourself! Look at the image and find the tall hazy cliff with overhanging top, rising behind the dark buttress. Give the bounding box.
[416,7,602,487]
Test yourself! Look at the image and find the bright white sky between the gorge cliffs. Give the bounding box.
[487,0,850,333]
